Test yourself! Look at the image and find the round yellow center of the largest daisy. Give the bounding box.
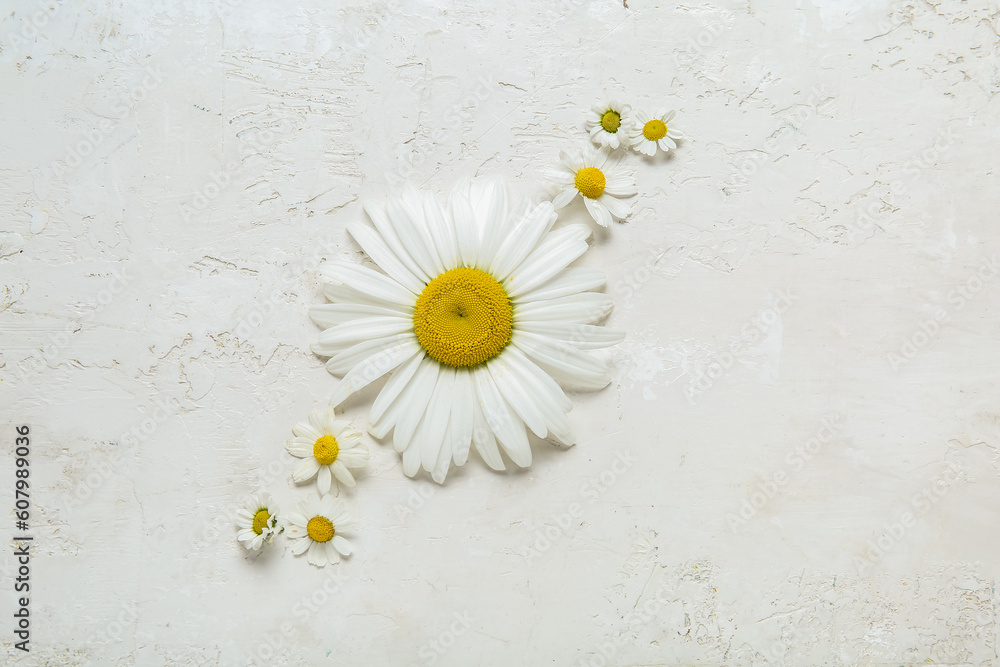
[413,267,514,367]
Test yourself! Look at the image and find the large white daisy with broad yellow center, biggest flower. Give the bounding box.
[310,181,623,483]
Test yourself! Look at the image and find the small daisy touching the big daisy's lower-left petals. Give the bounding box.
[285,407,368,494]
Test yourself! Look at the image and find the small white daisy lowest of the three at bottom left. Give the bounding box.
[284,494,356,567]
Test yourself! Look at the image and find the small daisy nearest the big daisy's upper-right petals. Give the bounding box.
[546,146,639,227]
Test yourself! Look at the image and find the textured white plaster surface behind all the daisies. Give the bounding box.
[0,0,1000,665]
